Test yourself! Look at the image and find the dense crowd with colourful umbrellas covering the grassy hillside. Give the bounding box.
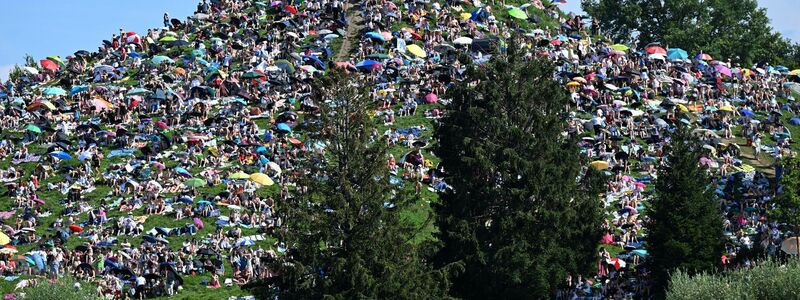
[0,0,800,299]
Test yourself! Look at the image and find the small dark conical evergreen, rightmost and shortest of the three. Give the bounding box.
[646,127,724,290]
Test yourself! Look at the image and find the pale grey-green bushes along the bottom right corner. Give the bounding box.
[667,260,800,300]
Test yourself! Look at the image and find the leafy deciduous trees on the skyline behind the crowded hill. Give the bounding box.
[582,0,796,66]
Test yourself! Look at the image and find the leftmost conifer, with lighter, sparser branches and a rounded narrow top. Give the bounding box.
[250,72,442,299]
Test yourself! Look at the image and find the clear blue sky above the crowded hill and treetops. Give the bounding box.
[0,0,800,79]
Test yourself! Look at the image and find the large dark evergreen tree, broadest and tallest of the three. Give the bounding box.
[435,44,602,299]
